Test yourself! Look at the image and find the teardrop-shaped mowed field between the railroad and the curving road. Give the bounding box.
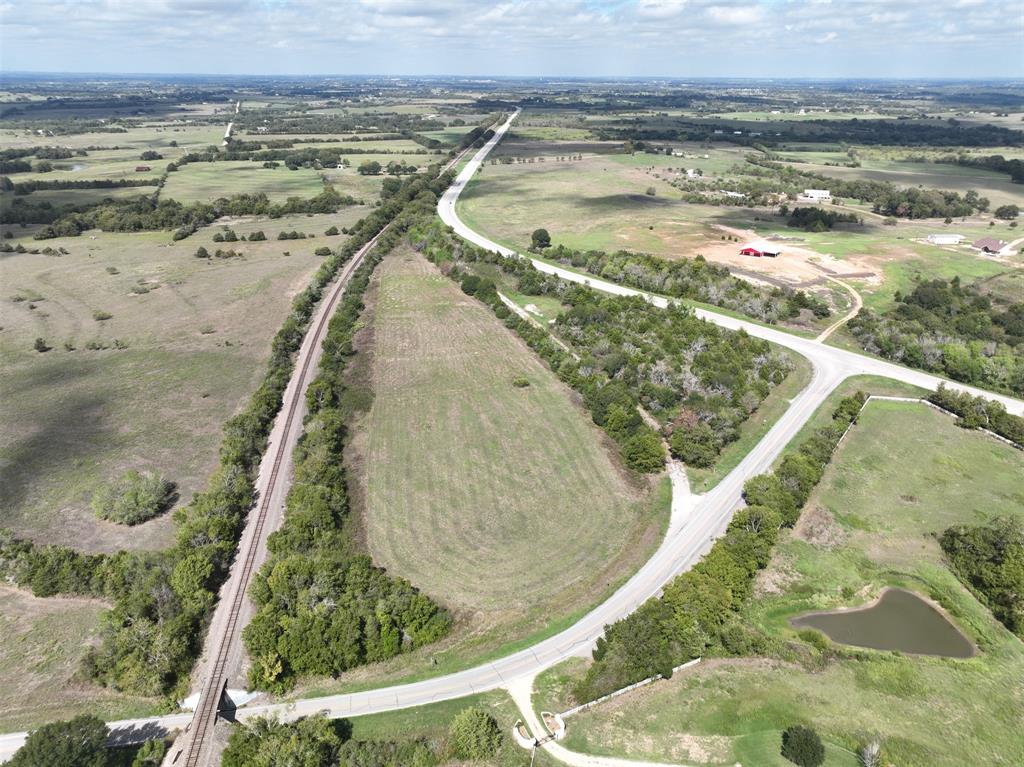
[339,250,668,663]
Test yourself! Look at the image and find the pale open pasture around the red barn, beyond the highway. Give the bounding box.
[459,128,1024,309]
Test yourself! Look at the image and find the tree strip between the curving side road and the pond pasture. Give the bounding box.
[575,393,866,700]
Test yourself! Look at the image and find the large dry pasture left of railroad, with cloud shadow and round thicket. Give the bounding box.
[0,207,365,551]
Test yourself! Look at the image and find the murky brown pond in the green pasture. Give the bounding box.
[791,589,975,657]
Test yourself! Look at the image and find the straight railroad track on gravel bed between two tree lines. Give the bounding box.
[166,123,499,767]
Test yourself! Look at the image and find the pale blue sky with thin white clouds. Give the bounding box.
[0,0,1024,78]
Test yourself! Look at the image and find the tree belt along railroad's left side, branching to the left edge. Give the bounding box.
[0,174,452,695]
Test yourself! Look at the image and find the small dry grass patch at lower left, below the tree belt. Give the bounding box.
[0,586,161,732]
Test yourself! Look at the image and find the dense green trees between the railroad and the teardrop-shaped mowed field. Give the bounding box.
[243,196,451,691]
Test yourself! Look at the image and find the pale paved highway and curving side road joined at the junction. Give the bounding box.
[0,110,1024,760]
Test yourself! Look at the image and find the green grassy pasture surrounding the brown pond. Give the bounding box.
[557,401,1024,767]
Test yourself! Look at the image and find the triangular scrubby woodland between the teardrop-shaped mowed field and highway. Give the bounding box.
[414,223,790,472]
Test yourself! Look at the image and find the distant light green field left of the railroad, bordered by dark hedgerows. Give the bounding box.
[161,161,325,204]
